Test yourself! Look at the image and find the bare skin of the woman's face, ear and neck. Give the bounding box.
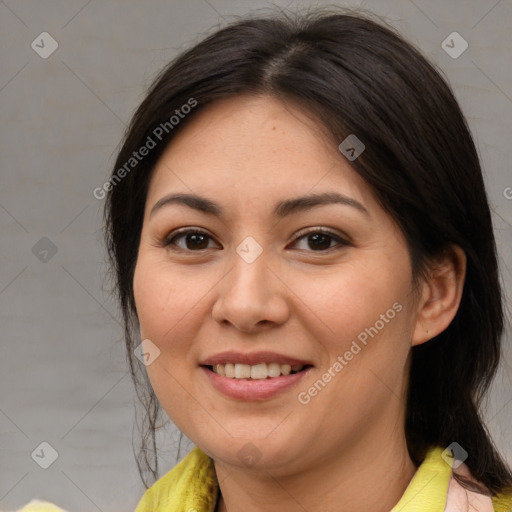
[134,96,465,512]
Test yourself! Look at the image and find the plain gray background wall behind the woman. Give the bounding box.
[0,0,512,512]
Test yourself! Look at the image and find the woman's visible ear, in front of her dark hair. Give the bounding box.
[412,245,466,346]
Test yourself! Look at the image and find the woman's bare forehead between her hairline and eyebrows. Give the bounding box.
[148,96,372,214]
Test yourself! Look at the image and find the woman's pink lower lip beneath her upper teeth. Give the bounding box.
[200,366,311,400]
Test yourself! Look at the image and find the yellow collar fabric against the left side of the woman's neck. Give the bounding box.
[135,447,218,512]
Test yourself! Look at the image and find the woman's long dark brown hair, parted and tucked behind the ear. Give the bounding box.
[104,10,512,494]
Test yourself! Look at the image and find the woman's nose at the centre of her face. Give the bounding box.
[212,252,290,333]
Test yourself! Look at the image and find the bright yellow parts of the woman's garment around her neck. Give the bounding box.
[135,446,512,512]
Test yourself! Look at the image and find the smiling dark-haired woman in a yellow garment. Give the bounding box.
[16,6,512,512]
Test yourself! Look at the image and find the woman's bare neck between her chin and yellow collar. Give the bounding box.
[215,435,417,512]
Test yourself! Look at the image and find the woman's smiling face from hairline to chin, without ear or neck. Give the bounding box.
[134,96,424,475]
